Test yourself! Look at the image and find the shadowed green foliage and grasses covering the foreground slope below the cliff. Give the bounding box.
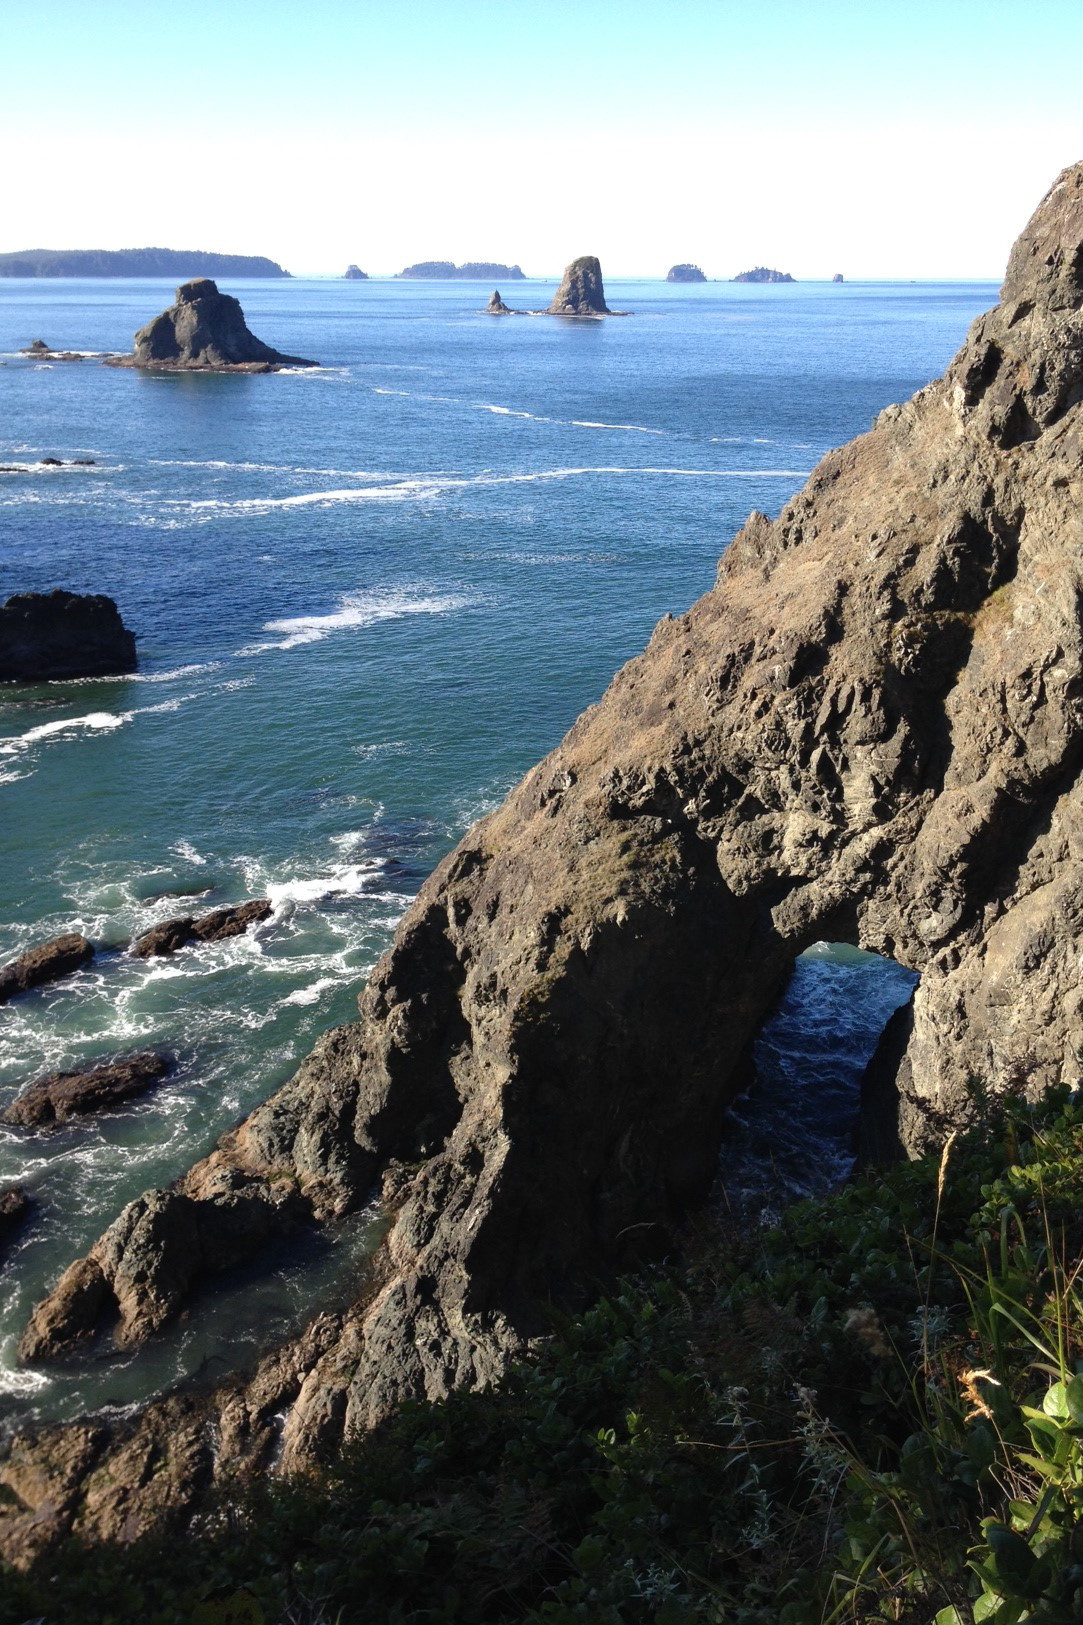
[0,1094,1083,1625]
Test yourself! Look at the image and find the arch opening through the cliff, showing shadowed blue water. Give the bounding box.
[717,943,919,1224]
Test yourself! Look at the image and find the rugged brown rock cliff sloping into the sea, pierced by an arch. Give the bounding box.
[0,164,1083,1552]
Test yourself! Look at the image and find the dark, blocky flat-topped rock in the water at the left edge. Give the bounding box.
[0,591,137,683]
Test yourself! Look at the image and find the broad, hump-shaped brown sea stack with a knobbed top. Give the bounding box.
[111,276,319,372]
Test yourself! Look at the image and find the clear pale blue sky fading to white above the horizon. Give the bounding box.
[8,0,1083,276]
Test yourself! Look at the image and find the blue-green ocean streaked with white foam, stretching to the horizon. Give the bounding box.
[0,281,995,1414]
